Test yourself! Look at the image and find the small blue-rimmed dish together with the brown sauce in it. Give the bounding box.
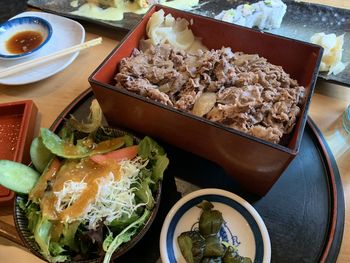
[0,16,52,59]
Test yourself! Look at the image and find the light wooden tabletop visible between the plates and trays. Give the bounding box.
[0,0,350,263]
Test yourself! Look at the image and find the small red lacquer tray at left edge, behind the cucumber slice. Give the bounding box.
[0,100,38,205]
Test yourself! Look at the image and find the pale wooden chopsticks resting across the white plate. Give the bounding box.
[0,37,102,78]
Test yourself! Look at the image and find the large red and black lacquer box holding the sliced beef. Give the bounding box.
[89,5,322,195]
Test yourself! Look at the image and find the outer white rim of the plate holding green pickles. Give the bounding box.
[159,188,271,263]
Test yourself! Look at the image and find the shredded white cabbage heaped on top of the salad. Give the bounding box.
[54,157,148,229]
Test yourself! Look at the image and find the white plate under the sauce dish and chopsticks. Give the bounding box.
[0,12,85,85]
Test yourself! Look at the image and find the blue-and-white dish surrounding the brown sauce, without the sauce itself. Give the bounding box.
[0,16,52,59]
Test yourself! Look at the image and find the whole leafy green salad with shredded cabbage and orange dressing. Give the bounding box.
[10,101,169,262]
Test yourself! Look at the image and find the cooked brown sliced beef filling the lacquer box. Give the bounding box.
[115,44,305,143]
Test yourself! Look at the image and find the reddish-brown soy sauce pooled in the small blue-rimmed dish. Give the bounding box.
[6,31,43,54]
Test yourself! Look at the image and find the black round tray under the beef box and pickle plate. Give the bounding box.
[51,89,345,263]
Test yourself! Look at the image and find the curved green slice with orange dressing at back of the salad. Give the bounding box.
[41,128,127,159]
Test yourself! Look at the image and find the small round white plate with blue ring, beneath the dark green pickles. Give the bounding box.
[159,189,271,263]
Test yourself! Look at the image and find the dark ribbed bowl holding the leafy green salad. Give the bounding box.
[13,128,162,263]
